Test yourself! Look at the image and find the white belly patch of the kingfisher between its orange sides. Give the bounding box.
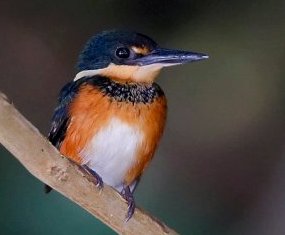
[80,118,144,190]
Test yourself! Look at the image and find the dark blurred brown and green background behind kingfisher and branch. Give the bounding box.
[0,0,285,235]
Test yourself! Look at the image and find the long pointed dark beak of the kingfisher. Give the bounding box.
[132,48,209,66]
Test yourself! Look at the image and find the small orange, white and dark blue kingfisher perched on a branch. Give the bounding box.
[46,30,208,220]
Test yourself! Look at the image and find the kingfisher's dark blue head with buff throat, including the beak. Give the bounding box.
[74,30,208,83]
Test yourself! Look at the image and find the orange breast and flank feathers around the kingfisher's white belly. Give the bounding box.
[60,85,167,185]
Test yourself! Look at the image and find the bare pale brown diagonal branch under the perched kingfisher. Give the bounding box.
[0,93,177,235]
